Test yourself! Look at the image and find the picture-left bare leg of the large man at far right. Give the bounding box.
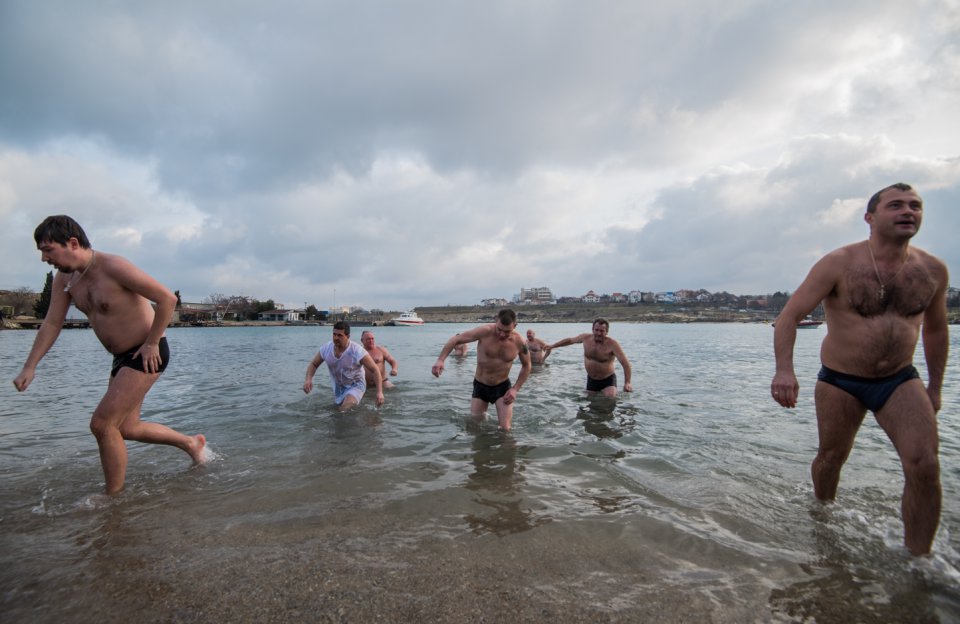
[810,381,867,500]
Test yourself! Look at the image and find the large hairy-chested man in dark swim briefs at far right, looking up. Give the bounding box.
[770,184,948,555]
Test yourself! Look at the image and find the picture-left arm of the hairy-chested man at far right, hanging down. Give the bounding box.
[770,250,842,407]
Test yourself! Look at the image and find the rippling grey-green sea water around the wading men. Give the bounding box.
[0,323,960,622]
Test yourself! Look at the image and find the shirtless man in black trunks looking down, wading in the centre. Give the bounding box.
[431,308,530,431]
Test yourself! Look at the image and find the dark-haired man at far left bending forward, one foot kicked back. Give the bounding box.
[13,215,206,494]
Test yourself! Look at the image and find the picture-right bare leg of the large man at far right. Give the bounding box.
[877,379,942,555]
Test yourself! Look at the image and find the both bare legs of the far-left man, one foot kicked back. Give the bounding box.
[90,368,206,494]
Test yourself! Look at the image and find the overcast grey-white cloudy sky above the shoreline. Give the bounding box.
[0,0,960,310]
